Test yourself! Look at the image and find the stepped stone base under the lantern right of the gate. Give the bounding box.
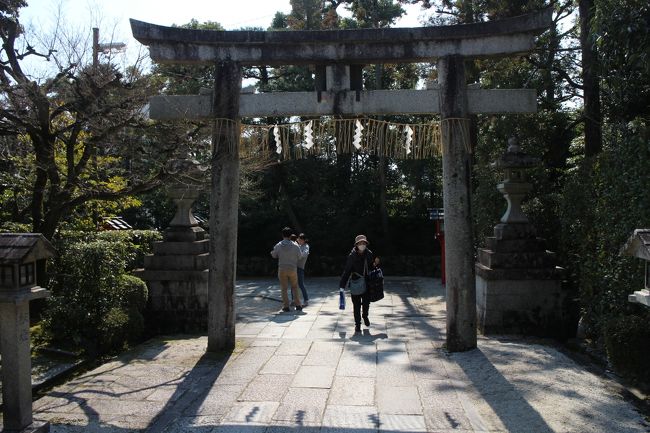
[475,223,566,337]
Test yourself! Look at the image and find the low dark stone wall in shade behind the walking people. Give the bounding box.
[237,255,440,278]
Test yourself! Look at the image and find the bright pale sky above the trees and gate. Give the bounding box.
[20,0,422,66]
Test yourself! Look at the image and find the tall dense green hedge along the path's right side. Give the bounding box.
[560,121,650,341]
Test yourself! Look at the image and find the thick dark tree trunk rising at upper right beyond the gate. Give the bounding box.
[578,0,603,157]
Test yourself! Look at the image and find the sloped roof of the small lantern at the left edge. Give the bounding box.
[0,233,56,265]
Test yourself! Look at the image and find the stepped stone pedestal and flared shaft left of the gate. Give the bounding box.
[136,185,210,333]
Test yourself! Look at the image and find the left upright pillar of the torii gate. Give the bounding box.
[207,61,242,352]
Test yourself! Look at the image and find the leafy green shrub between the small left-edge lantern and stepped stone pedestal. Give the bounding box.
[43,235,147,356]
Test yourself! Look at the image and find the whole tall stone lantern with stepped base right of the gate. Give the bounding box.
[475,138,565,336]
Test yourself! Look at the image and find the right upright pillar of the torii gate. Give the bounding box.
[438,56,476,352]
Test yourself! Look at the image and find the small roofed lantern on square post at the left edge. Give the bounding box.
[0,233,55,433]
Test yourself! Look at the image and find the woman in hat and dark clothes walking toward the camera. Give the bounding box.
[339,235,375,333]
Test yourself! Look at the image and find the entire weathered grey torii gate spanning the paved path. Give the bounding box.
[131,9,552,351]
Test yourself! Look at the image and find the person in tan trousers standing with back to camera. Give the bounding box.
[271,227,302,311]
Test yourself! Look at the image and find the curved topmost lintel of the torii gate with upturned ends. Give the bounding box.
[131,8,552,66]
